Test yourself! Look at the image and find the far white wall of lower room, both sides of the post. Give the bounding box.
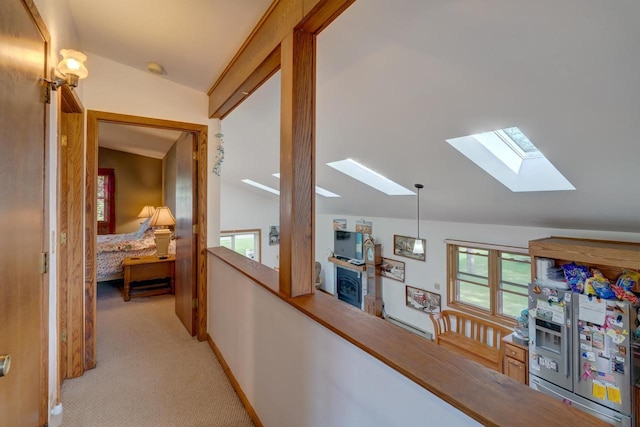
[219,183,640,340]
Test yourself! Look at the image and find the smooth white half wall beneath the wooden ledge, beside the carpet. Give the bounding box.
[208,256,478,427]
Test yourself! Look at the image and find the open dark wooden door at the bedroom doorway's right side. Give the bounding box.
[175,132,197,336]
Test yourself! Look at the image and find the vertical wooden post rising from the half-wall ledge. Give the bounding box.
[280,29,316,297]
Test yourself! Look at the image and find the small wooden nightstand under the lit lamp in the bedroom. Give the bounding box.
[122,254,176,301]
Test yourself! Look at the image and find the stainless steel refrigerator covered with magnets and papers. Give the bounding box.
[529,283,637,427]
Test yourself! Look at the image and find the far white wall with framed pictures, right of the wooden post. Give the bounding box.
[316,215,640,338]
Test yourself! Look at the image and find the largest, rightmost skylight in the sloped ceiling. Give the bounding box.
[447,127,575,192]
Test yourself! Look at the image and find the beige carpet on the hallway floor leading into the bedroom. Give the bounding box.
[61,284,253,427]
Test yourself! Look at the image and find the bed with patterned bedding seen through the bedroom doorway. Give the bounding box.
[97,219,176,282]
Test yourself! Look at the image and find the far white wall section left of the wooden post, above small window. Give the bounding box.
[221,183,280,268]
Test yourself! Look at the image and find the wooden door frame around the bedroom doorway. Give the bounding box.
[84,110,208,369]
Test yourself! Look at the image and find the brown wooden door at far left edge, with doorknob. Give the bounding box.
[0,0,48,426]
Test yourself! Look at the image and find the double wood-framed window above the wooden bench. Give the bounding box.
[447,241,531,323]
